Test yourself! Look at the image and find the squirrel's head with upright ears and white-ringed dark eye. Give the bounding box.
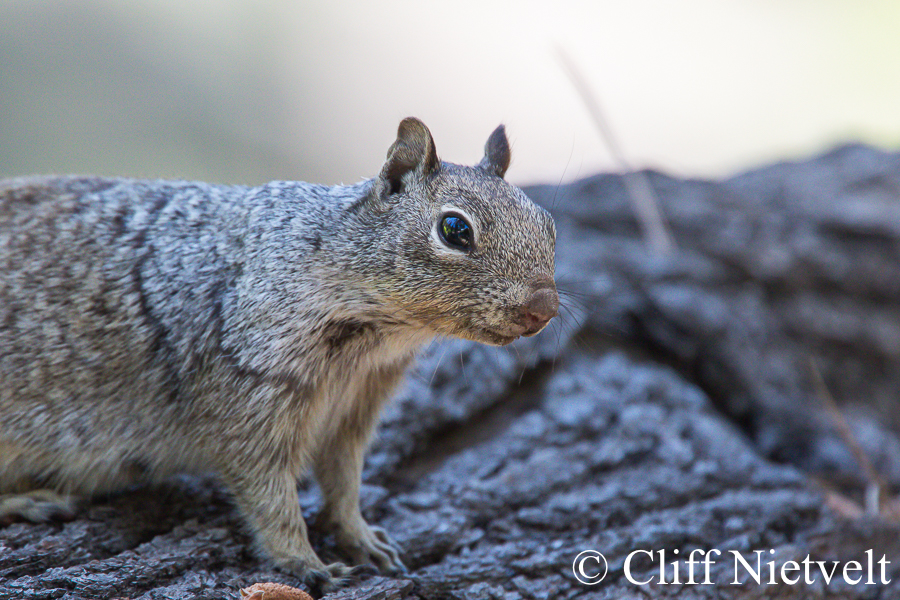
[365,118,559,345]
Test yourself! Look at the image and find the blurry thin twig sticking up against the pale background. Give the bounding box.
[556,46,675,255]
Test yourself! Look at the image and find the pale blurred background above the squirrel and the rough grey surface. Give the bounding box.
[0,0,900,184]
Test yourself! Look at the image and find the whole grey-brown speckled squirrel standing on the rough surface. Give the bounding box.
[0,118,559,589]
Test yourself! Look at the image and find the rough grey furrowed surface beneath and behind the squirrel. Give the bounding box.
[0,146,900,600]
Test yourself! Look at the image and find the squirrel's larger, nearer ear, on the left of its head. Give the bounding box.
[380,117,441,194]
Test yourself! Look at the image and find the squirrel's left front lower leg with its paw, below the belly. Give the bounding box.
[225,471,357,592]
